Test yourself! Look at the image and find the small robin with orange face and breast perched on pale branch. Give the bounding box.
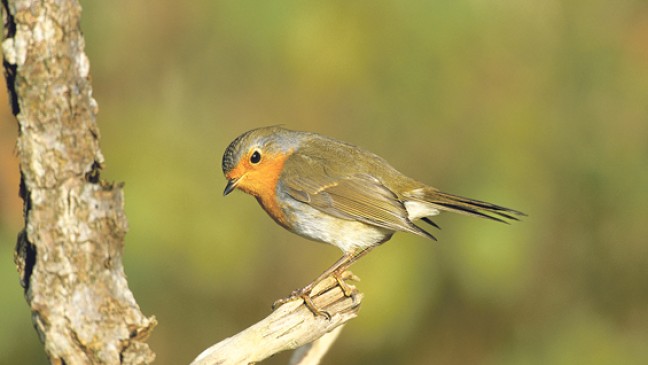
[222,125,525,315]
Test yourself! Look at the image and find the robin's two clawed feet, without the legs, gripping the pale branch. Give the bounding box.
[272,271,360,319]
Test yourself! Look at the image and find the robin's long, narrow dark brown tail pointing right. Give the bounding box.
[424,190,526,223]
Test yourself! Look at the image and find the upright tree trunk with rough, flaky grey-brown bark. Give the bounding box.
[2,0,156,364]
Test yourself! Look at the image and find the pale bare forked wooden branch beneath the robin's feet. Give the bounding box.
[191,272,363,365]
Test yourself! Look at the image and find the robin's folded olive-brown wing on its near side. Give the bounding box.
[281,155,435,239]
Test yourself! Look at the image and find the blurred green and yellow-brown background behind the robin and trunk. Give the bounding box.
[0,0,648,364]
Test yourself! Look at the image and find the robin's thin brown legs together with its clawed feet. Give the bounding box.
[272,247,373,318]
